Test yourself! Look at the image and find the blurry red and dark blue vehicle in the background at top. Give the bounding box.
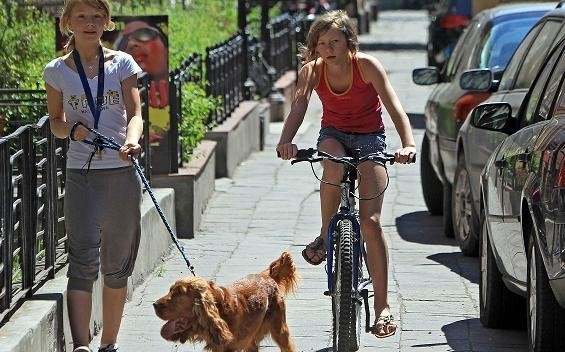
[426,0,472,68]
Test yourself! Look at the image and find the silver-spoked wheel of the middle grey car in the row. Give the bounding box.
[451,156,479,257]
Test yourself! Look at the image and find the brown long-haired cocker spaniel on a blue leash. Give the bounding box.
[153,252,298,352]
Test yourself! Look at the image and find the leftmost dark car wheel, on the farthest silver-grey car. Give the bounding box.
[420,134,443,215]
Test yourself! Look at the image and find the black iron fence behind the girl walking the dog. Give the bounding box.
[0,76,151,321]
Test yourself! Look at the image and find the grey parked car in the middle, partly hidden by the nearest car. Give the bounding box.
[451,8,565,255]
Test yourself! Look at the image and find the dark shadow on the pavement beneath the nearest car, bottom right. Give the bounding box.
[438,318,528,352]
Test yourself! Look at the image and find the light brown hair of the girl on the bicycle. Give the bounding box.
[298,10,359,65]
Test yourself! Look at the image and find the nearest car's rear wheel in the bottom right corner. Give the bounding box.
[527,228,565,352]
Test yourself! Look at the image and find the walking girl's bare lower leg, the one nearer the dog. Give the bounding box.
[100,286,127,344]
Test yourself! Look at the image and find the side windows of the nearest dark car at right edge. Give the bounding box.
[523,46,565,125]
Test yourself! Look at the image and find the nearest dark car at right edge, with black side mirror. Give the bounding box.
[471,37,565,352]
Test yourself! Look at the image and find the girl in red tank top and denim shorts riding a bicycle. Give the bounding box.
[277,10,416,337]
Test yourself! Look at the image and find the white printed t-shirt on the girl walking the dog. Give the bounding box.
[43,51,141,169]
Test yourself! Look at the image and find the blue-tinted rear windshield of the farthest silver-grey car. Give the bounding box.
[479,16,538,70]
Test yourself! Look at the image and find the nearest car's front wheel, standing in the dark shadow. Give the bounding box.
[479,206,526,328]
